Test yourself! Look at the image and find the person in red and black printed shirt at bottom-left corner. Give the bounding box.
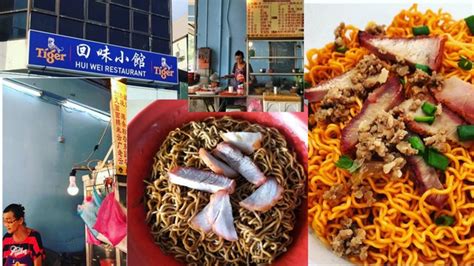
[3,204,45,266]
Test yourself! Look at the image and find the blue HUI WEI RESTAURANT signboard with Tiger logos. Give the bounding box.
[28,30,178,84]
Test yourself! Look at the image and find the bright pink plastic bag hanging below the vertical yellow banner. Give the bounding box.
[94,192,127,246]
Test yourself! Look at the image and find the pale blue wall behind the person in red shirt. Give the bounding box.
[2,81,111,252]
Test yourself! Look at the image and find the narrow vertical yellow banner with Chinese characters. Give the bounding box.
[110,78,127,175]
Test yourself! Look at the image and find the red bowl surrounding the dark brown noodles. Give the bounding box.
[127,100,308,266]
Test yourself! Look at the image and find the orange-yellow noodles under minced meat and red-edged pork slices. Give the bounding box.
[305,5,474,265]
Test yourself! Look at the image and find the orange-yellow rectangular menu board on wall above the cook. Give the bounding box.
[247,0,304,38]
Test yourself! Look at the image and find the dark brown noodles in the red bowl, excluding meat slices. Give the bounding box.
[145,117,306,265]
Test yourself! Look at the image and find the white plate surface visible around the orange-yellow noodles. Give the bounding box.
[304,0,474,265]
